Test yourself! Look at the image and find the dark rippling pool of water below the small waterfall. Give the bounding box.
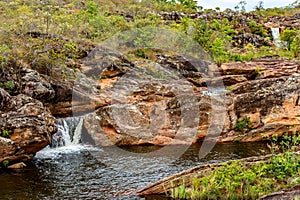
[0,143,266,199]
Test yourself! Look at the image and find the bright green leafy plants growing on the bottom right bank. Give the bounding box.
[170,133,300,199]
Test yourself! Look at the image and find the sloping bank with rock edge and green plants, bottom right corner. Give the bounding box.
[136,142,300,199]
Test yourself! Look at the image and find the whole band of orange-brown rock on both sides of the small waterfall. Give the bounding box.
[0,48,300,161]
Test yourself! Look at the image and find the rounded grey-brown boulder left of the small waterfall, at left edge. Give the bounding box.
[0,88,57,164]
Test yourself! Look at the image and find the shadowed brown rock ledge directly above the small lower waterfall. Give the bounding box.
[45,73,109,117]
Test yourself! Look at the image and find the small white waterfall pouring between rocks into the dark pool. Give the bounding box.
[50,117,83,148]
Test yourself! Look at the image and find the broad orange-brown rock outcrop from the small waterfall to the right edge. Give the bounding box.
[79,54,300,146]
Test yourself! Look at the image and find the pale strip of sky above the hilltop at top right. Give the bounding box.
[198,0,295,11]
